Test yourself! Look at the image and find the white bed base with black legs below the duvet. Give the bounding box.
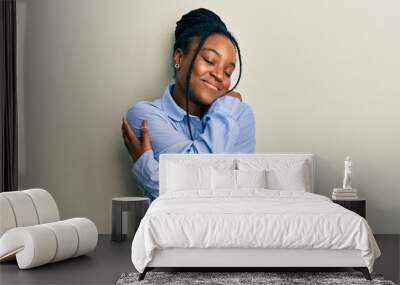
[139,248,371,280]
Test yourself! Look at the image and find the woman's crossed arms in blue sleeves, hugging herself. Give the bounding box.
[123,96,255,200]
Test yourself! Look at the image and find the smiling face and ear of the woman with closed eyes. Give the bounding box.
[174,34,236,106]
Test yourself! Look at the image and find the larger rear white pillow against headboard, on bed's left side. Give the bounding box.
[167,163,211,191]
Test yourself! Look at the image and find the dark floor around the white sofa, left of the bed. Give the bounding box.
[0,235,135,285]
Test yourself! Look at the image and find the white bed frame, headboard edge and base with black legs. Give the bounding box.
[139,153,371,280]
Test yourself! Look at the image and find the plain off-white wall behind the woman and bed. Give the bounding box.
[17,0,400,233]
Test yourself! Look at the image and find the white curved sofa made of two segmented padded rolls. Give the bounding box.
[0,189,98,269]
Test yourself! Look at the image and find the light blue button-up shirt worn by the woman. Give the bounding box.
[127,84,255,201]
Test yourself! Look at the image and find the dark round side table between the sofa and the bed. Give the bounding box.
[111,197,150,241]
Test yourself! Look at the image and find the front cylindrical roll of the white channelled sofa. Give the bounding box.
[0,218,98,269]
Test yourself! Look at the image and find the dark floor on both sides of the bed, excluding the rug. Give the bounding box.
[0,235,400,285]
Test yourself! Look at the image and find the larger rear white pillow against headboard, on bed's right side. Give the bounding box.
[238,159,311,191]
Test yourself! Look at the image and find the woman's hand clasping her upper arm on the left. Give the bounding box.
[121,118,152,161]
